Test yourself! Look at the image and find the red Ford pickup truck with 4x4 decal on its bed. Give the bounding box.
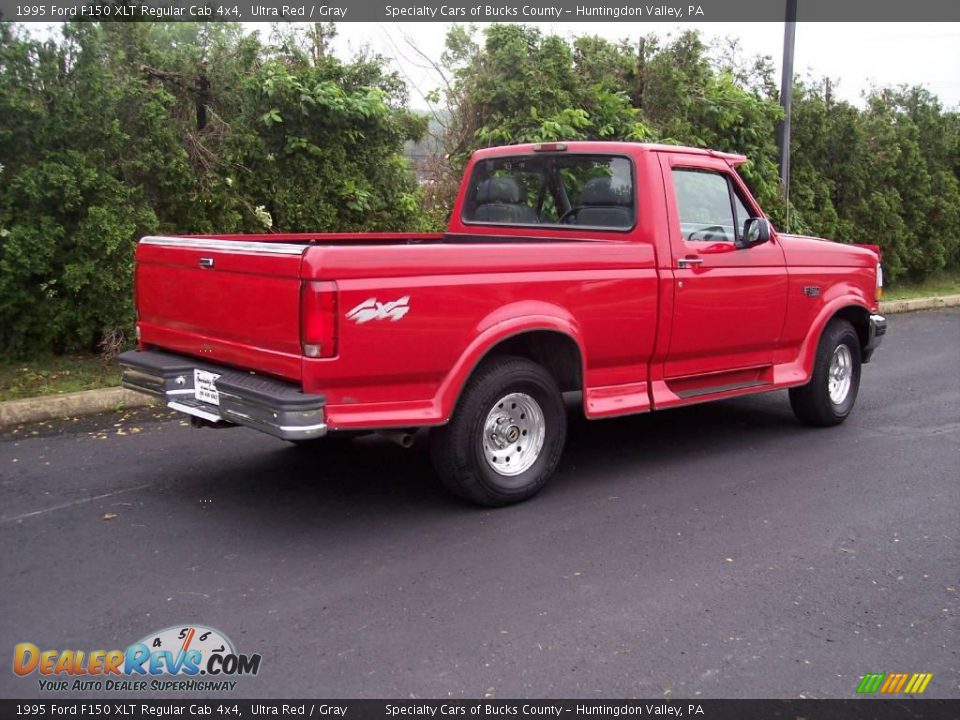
[120,142,886,506]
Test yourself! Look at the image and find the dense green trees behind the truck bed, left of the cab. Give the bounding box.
[0,23,425,354]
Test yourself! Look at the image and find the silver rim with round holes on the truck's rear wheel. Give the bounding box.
[483,393,547,477]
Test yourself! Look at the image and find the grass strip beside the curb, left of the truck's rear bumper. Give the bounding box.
[0,355,120,401]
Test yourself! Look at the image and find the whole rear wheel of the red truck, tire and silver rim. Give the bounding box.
[430,356,567,507]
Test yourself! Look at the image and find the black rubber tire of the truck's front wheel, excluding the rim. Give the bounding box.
[790,319,861,427]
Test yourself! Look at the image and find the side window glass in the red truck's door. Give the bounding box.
[672,168,748,242]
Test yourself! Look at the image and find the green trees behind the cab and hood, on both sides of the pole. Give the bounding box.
[432,24,960,281]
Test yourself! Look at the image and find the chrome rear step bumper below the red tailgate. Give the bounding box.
[119,350,327,440]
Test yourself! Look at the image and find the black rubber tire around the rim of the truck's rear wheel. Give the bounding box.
[430,356,567,507]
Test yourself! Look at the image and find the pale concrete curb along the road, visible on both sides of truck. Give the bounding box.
[0,295,960,427]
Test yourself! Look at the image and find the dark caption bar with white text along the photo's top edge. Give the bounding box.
[0,0,960,22]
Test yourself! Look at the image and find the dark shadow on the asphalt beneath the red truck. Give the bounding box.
[167,393,815,525]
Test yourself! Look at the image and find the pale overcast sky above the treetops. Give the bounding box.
[310,22,960,108]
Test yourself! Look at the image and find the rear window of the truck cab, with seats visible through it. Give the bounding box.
[462,153,636,230]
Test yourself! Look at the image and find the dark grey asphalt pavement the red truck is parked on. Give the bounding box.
[0,310,960,699]
